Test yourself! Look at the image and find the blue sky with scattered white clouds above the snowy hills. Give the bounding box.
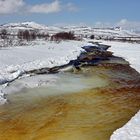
[0,0,140,26]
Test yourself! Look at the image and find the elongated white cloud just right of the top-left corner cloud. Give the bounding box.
[29,0,61,14]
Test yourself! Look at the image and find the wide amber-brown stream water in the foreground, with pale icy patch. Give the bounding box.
[0,65,140,140]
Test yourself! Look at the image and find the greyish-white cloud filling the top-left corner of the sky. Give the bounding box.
[0,0,25,14]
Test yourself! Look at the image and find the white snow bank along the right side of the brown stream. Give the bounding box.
[98,41,140,140]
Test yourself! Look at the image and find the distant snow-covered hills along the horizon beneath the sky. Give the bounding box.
[0,22,138,37]
